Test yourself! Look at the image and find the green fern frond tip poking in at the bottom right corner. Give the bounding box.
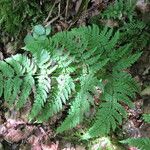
[120,138,150,150]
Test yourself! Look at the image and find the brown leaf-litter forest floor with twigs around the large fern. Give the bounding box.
[0,0,150,150]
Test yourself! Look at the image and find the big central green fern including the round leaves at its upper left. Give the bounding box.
[0,25,141,139]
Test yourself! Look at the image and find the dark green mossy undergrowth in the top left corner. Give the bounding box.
[0,0,52,37]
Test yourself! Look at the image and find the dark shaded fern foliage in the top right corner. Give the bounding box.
[99,0,150,49]
